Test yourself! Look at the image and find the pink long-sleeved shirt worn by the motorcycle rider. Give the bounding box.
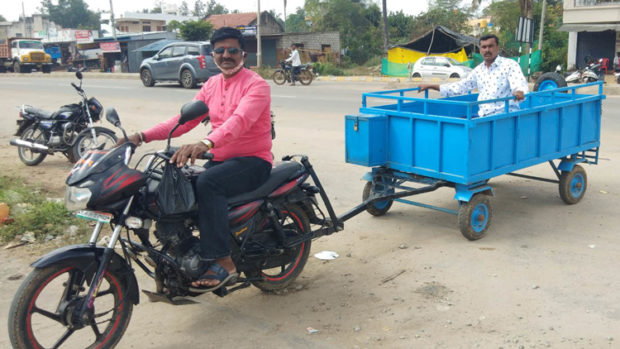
[144,68,273,163]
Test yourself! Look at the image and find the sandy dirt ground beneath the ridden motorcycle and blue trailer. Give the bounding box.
[0,79,620,349]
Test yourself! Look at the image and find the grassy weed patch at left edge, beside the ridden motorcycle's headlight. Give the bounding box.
[0,176,87,242]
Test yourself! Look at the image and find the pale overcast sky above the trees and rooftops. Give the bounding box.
[0,0,436,21]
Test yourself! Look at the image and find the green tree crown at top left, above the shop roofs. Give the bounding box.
[41,0,100,30]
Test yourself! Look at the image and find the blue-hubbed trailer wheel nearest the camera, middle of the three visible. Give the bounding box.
[459,194,493,241]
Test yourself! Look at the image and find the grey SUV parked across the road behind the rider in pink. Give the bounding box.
[140,41,220,88]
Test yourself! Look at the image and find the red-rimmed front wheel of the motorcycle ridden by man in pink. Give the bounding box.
[8,260,133,349]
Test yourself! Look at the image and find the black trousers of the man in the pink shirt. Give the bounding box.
[196,156,271,259]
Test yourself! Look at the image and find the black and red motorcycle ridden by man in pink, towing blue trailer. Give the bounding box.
[9,101,346,348]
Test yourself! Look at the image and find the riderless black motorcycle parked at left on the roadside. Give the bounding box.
[10,71,117,166]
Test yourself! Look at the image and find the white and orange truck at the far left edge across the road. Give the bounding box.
[0,38,52,73]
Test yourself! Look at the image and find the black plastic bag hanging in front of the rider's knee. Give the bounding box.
[157,163,196,215]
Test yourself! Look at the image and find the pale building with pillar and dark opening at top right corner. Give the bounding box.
[560,0,620,69]
